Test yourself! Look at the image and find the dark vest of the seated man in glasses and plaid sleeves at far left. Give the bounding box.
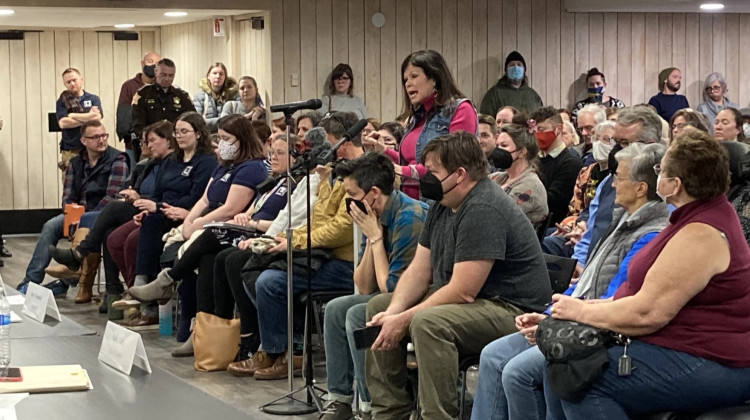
[70,146,130,211]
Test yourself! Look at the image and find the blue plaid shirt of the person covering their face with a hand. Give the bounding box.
[359,191,429,292]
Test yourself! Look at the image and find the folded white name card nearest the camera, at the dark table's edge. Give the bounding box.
[99,321,151,375]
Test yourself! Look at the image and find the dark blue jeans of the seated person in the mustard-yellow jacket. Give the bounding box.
[250,260,354,353]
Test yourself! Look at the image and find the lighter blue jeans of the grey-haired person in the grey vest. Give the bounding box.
[471,333,545,420]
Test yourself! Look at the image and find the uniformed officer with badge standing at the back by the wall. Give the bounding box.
[131,58,195,161]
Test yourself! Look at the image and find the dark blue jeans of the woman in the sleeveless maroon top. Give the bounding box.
[545,341,750,420]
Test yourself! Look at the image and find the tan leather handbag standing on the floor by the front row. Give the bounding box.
[193,312,240,372]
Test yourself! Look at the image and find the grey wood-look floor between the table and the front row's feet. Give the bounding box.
[0,236,325,420]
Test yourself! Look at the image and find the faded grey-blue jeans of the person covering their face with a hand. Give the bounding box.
[323,294,375,405]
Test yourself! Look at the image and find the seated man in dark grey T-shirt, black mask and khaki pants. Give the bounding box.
[365,132,551,419]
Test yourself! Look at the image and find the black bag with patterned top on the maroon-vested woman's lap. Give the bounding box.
[536,317,622,402]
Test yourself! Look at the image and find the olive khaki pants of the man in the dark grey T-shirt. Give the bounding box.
[365,293,523,420]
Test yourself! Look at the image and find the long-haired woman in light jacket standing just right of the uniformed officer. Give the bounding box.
[193,63,241,133]
